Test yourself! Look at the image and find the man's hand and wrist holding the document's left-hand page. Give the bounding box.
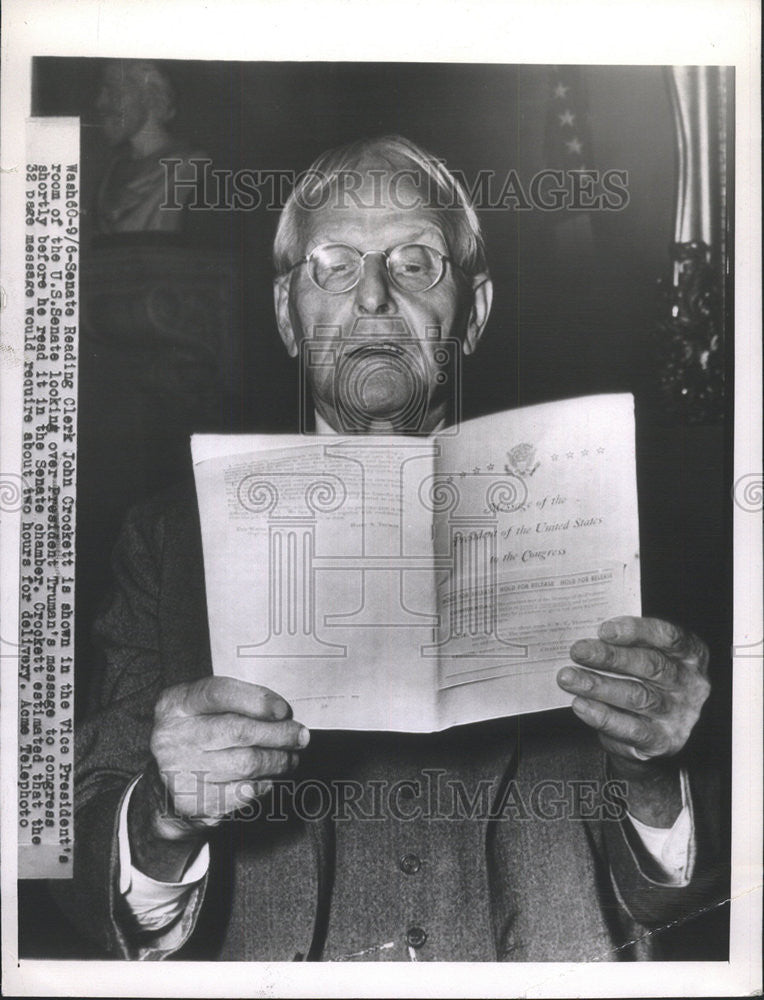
[128,677,310,882]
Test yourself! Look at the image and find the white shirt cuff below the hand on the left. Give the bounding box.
[118,775,210,931]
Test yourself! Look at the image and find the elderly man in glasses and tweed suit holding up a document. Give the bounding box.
[61,137,714,961]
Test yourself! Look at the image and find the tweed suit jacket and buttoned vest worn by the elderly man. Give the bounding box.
[58,489,723,961]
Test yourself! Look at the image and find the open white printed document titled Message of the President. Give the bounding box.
[192,394,640,732]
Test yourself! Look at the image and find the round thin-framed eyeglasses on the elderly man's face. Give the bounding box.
[287,243,454,294]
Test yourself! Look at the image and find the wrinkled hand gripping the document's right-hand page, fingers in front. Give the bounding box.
[557,617,711,761]
